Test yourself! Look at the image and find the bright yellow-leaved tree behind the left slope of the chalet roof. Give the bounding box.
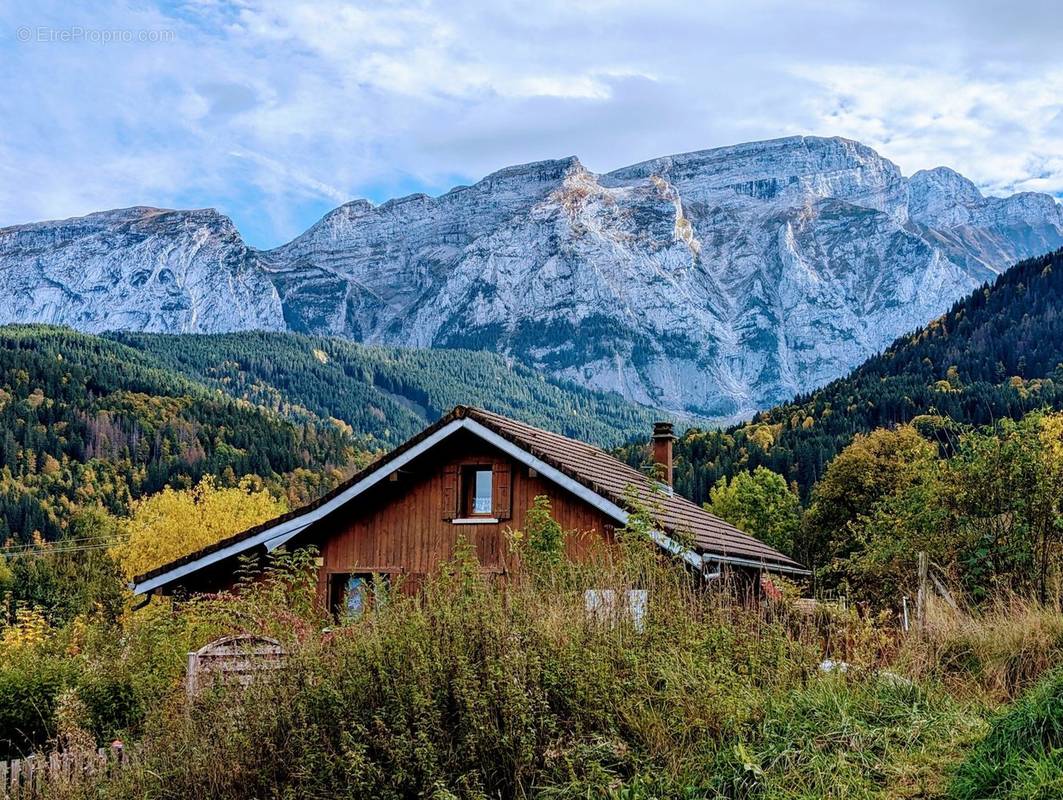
[115,476,288,578]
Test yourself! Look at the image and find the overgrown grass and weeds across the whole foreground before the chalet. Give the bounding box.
[6,533,1063,800]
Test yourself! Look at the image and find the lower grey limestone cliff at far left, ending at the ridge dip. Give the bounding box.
[0,208,284,333]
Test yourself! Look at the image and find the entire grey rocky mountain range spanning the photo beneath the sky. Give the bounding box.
[0,137,1063,418]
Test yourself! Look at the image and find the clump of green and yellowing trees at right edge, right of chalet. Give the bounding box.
[824,412,1063,605]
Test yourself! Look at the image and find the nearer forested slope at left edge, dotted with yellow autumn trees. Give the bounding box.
[0,326,366,542]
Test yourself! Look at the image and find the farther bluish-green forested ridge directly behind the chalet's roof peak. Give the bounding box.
[108,333,655,446]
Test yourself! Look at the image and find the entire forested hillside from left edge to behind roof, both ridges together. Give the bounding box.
[0,325,654,542]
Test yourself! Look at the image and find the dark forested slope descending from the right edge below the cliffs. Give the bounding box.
[654,251,1063,503]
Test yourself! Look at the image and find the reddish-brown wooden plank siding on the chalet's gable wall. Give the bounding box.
[304,427,612,596]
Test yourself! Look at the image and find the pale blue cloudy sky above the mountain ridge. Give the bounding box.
[0,0,1063,248]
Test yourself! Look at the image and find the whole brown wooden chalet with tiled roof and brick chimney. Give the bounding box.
[132,406,806,610]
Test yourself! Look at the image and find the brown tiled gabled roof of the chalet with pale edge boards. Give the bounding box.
[132,406,807,594]
